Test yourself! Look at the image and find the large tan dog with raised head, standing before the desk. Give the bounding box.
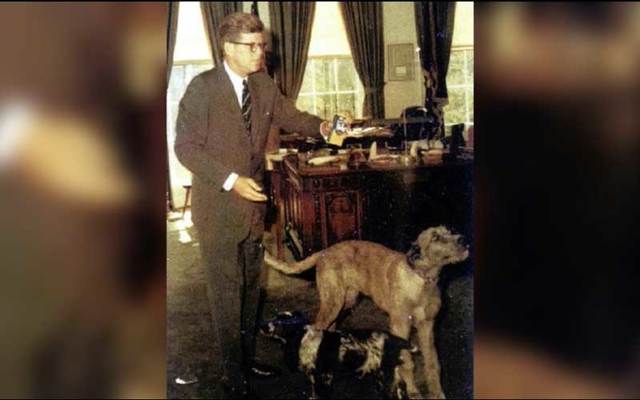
[265,226,469,398]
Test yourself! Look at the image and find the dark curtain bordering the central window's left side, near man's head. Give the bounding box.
[269,1,316,100]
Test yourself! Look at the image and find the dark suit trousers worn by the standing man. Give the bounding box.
[200,209,264,387]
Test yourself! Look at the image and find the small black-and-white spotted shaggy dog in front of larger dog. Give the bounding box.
[260,312,417,399]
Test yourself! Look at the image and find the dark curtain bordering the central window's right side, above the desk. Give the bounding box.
[340,1,385,118]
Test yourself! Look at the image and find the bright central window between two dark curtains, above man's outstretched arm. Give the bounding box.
[296,2,364,119]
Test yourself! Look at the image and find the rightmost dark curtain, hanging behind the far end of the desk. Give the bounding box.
[414,1,456,137]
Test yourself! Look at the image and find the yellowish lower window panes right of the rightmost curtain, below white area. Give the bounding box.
[444,48,473,125]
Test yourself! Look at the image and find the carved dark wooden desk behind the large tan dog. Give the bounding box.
[272,154,473,257]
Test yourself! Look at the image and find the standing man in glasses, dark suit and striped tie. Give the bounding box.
[175,13,331,395]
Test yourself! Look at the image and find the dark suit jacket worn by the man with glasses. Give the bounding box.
[175,67,322,242]
